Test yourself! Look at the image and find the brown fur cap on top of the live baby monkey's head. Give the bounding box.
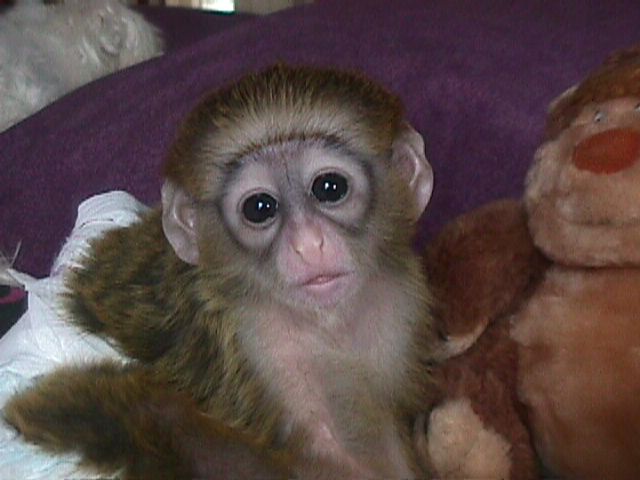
[164,64,404,198]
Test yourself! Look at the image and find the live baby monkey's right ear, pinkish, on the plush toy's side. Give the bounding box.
[392,123,433,220]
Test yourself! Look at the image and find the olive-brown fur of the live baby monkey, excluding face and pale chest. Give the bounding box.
[4,66,435,478]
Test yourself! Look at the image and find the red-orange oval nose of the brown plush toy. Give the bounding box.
[573,128,640,175]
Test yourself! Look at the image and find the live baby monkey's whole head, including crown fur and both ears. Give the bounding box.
[162,65,433,309]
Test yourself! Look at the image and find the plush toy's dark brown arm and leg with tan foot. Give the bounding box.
[424,200,548,480]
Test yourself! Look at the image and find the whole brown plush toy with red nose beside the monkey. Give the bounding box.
[425,48,640,479]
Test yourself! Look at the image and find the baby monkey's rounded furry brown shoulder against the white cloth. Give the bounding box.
[63,206,192,359]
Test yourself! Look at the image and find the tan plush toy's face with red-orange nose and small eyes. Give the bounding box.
[525,97,640,265]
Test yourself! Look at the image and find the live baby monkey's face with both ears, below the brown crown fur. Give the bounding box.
[163,127,433,312]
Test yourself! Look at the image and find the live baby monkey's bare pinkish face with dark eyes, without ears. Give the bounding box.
[210,141,378,307]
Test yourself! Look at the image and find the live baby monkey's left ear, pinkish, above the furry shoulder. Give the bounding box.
[162,180,200,265]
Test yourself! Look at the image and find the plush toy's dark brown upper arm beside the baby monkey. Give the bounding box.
[424,200,548,354]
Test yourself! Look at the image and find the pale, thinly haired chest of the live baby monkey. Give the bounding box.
[243,286,414,463]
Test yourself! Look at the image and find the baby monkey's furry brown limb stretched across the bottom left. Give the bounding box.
[3,362,287,479]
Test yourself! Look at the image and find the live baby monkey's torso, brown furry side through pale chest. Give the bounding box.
[67,212,428,475]
